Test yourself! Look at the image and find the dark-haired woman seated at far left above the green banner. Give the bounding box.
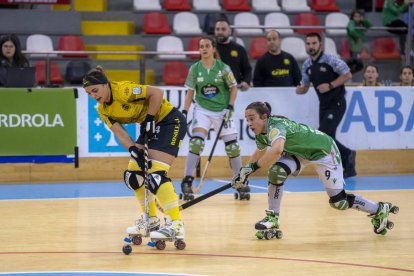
[0,34,29,68]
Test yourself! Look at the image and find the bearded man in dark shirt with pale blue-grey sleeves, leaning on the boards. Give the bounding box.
[296,33,356,178]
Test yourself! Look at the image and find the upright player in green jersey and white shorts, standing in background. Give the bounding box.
[181,36,248,200]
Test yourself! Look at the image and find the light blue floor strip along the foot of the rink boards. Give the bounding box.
[0,175,414,200]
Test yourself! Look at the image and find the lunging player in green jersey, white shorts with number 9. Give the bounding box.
[232,102,398,239]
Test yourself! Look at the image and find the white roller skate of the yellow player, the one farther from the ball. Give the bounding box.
[148,218,186,250]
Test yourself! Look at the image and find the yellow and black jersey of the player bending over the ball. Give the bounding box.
[98,81,173,127]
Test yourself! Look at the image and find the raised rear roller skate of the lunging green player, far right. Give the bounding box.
[369,202,400,235]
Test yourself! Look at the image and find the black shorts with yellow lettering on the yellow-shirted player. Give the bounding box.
[136,107,187,157]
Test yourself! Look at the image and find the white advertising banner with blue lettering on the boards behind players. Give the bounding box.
[77,86,414,157]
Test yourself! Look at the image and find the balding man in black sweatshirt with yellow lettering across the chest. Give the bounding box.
[253,30,302,87]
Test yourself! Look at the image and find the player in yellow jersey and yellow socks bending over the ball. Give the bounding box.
[83,67,187,248]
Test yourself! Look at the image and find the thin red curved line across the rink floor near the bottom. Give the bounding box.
[0,251,414,272]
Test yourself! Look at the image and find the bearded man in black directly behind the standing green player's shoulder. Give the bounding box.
[214,19,252,91]
